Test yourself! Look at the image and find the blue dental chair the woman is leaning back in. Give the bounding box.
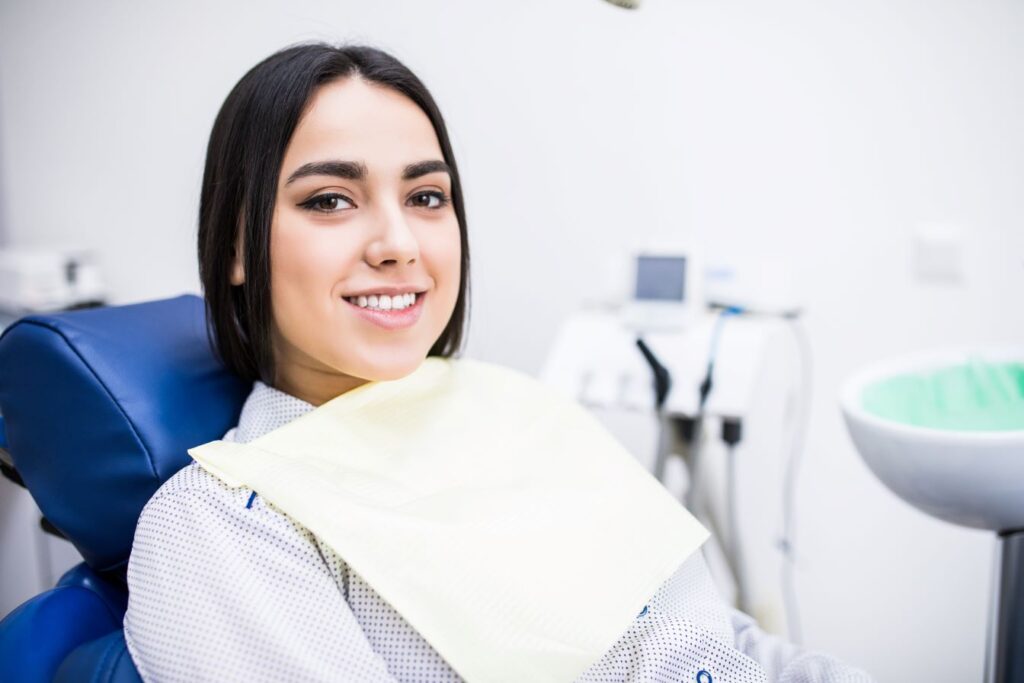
[0,295,251,683]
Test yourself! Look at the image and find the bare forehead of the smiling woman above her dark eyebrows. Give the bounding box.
[282,77,441,176]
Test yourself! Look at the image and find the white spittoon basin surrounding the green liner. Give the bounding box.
[840,348,1024,531]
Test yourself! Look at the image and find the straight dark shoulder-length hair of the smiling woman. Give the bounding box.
[199,43,469,384]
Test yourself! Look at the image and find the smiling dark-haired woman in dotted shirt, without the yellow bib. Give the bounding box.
[125,44,870,682]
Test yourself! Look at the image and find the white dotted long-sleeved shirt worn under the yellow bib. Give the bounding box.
[124,382,871,683]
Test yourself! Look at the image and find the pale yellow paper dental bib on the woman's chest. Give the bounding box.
[188,357,709,683]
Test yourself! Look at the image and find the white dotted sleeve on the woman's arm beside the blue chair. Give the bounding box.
[124,487,395,682]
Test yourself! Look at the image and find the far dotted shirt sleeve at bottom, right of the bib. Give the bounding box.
[729,607,874,683]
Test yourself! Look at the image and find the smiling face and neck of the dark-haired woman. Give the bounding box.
[237,77,461,405]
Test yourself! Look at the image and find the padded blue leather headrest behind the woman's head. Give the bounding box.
[0,295,252,571]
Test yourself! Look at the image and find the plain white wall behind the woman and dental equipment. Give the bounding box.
[0,0,1024,682]
